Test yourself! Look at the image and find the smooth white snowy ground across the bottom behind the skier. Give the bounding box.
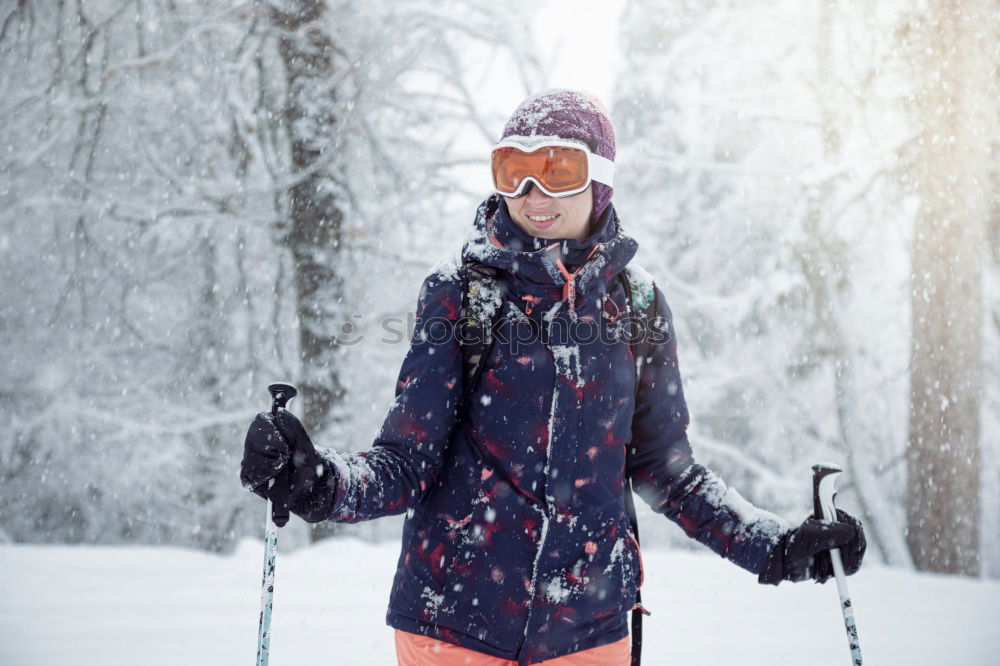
[0,540,1000,666]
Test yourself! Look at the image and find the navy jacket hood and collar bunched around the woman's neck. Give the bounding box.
[462,194,639,307]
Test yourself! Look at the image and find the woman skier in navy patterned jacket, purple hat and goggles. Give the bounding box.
[241,90,865,665]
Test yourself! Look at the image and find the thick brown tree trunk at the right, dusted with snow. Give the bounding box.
[907,0,995,575]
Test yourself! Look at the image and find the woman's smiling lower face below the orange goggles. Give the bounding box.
[504,187,594,241]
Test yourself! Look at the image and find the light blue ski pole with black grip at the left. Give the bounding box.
[257,384,298,666]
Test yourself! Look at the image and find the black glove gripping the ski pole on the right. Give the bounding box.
[757,509,867,585]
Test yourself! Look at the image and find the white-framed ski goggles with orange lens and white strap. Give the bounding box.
[492,139,615,198]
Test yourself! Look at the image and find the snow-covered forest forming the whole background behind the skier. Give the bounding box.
[0,0,1000,577]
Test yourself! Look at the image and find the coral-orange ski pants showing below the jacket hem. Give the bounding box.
[396,629,632,666]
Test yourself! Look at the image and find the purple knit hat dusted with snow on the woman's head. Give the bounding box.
[500,88,615,221]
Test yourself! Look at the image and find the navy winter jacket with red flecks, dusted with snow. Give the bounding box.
[330,197,788,664]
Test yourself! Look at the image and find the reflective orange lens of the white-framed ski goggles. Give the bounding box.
[493,146,589,196]
